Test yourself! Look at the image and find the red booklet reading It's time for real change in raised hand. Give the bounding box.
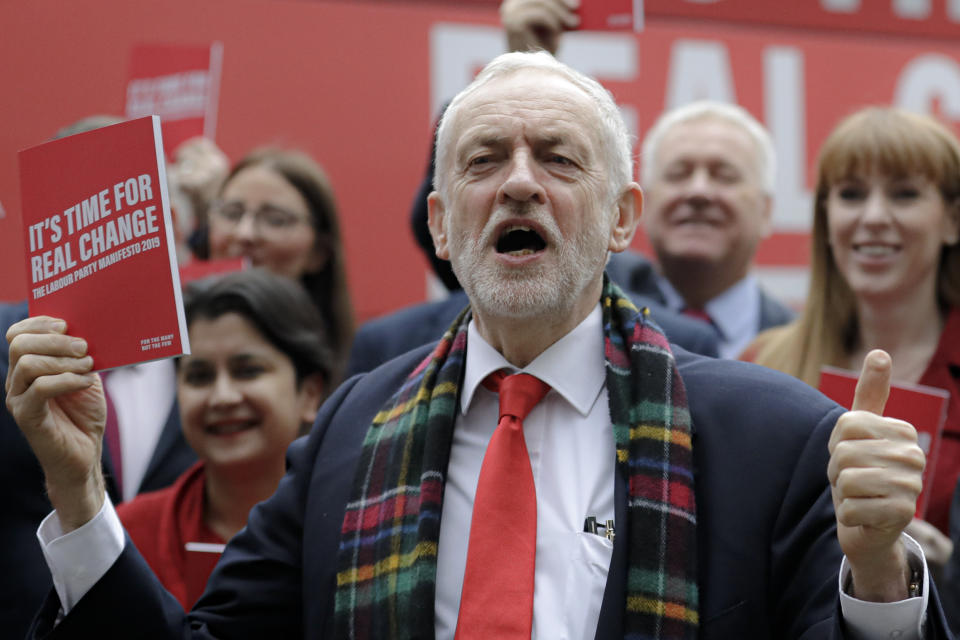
[19,116,190,370]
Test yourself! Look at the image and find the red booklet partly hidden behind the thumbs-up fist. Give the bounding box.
[819,367,950,519]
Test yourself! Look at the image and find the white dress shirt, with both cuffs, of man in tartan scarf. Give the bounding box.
[37,305,929,640]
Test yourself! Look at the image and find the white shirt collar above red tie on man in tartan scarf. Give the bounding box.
[460,304,606,416]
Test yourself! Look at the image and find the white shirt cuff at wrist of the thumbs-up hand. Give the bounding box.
[840,533,930,640]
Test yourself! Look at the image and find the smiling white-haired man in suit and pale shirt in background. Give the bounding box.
[628,101,793,358]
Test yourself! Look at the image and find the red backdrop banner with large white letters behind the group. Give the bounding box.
[0,0,960,320]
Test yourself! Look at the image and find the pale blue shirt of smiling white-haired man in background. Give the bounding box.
[657,273,760,358]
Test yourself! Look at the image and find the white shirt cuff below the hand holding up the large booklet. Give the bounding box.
[37,496,126,615]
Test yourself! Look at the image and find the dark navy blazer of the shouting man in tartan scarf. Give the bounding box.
[33,347,951,640]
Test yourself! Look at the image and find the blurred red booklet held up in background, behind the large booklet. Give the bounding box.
[126,42,223,157]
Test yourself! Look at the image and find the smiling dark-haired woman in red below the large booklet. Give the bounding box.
[117,269,331,608]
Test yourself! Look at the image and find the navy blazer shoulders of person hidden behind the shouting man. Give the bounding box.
[346,264,718,378]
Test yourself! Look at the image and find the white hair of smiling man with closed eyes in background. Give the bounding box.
[640,100,777,196]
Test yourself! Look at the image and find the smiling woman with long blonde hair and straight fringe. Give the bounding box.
[744,107,960,534]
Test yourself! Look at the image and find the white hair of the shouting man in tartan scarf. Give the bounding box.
[433,51,633,202]
